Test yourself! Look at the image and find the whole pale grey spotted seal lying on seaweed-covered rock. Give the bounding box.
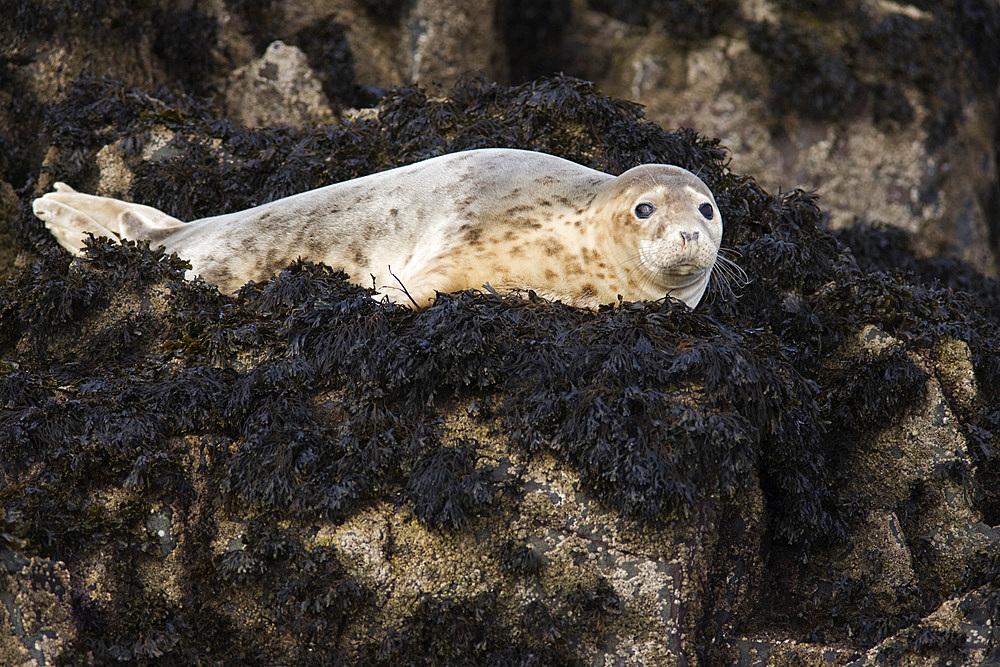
[33,148,722,308]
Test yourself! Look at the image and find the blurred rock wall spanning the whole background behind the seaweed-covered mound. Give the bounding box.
[0,0,1000,275]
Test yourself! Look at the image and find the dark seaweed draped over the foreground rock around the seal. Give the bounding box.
[0,77,1000,664]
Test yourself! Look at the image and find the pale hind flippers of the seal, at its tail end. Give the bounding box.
[31,183,184,255]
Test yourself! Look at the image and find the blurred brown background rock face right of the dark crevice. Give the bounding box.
[567,2,1000,275]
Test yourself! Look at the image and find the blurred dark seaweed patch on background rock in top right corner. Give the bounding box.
[747,0,984,143]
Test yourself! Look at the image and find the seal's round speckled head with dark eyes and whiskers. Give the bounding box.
[596,164,722,308]
